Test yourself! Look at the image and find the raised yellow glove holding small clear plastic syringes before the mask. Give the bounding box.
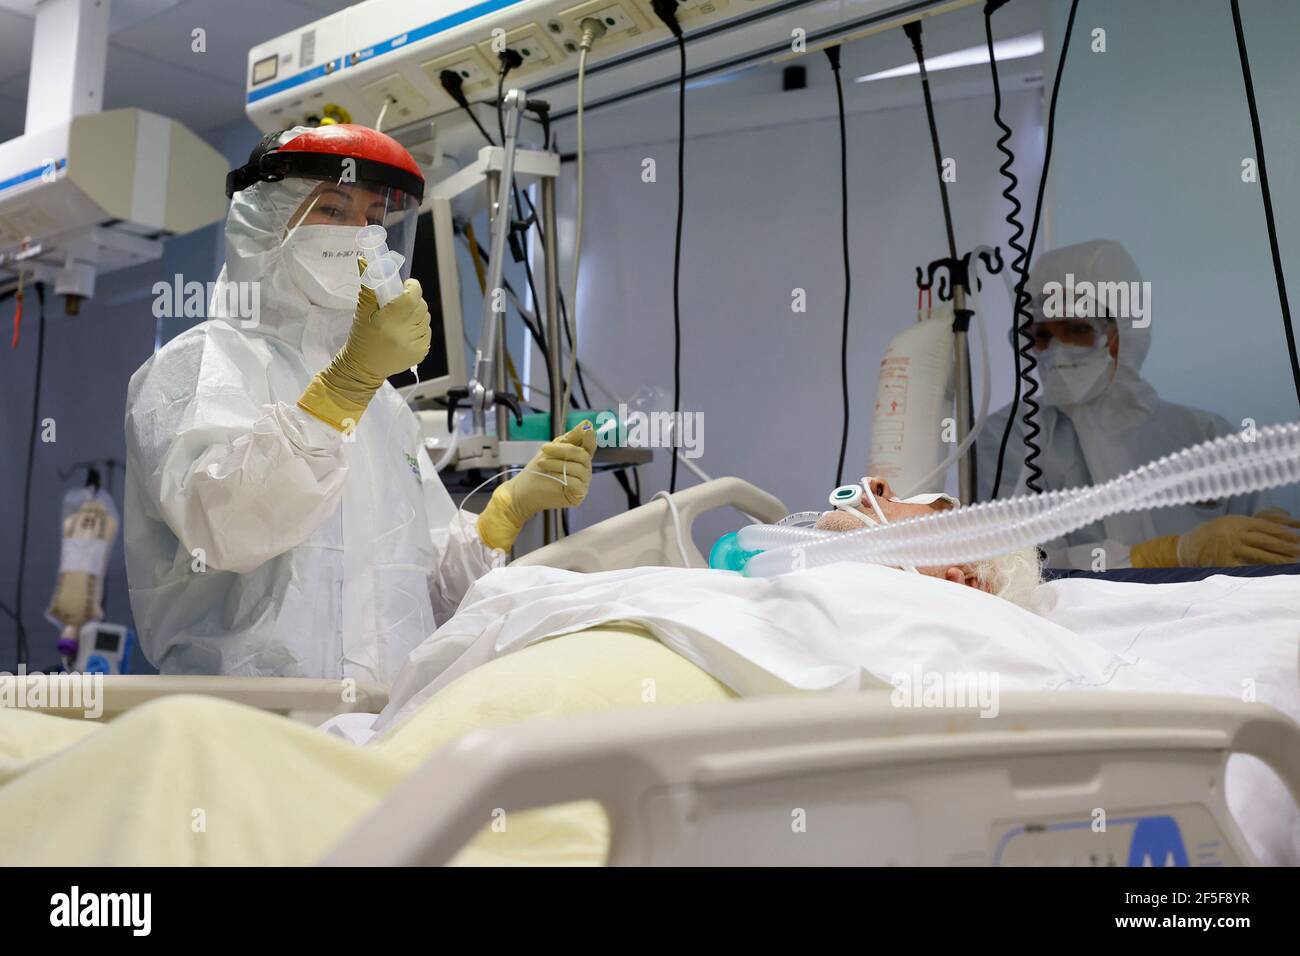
[298,270,433,432]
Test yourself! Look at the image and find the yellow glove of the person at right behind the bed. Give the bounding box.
[1130,509,1300,567]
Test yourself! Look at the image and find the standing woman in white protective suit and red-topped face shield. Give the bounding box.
[125,125,595,682]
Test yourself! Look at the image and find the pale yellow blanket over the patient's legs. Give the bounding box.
[0,624,732,866]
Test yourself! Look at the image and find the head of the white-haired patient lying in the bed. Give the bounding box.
[815,477,1043,610]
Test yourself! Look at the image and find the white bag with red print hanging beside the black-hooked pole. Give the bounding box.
[867,306,956,494]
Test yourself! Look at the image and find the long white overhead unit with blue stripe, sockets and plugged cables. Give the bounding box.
[247,0,976,148]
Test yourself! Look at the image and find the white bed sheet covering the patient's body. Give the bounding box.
[376,563,1300,864]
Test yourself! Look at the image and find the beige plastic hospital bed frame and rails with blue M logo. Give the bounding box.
[2,479,1300,865]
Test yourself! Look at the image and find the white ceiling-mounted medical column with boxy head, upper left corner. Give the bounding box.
[0,0,228,312]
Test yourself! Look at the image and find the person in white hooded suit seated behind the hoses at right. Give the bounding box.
[978,239,1300,570]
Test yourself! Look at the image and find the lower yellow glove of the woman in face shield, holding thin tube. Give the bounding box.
[478,421,595,551]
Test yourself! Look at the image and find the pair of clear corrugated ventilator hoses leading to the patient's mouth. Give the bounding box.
[736,423,1300,578]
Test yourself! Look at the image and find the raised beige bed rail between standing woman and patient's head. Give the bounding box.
[514,477,789,571]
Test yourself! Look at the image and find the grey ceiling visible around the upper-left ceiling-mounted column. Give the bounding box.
[0,0,356,142]
